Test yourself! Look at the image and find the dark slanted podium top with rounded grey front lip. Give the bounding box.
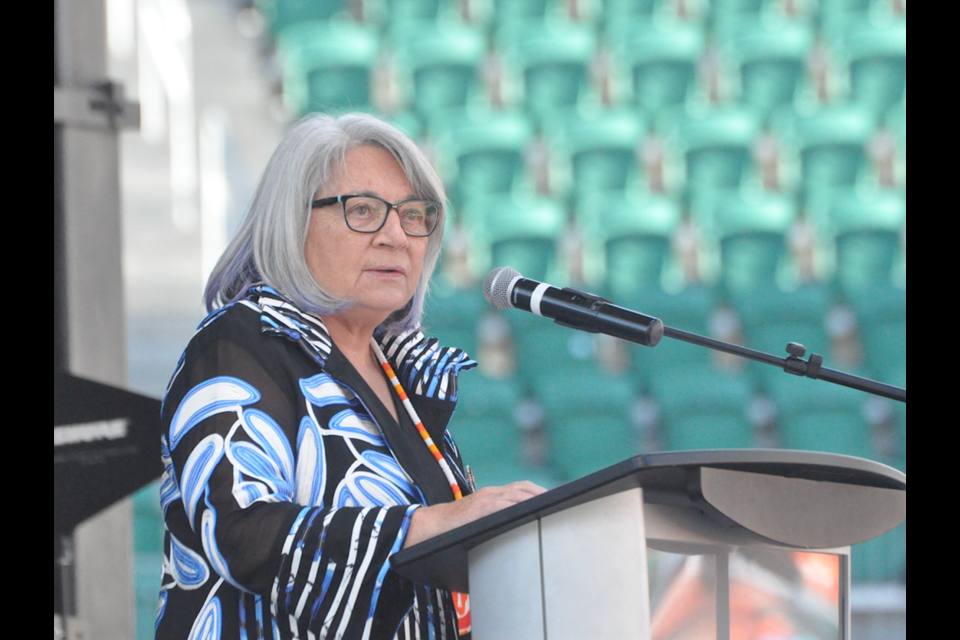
[391,449,907,590]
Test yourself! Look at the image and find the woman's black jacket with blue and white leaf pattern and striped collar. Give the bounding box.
[157,287,476,640]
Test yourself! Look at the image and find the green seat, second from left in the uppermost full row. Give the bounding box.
[391,22,487,119]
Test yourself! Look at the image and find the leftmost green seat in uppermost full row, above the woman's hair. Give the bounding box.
[277,22,380,117]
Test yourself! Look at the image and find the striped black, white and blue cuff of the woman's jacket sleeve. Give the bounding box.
[272,506,417,640]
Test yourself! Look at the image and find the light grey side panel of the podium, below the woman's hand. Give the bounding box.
[469,489,650,640]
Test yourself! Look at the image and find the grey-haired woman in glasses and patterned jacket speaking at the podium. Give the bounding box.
[157,115,543,640]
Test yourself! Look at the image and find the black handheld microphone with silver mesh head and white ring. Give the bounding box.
[483,267,663,347]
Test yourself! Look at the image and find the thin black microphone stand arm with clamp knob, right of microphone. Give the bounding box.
[663,326,907,404]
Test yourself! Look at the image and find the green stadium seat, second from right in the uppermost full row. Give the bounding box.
[729,19,814,118]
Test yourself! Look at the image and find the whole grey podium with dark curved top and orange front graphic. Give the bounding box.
[391,450,907,640]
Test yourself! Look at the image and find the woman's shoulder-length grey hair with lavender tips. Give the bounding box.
[204,113,446,333]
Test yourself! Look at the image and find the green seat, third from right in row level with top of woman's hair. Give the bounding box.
[546,110,646,202]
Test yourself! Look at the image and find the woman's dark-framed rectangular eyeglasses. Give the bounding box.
[313,196,441,238]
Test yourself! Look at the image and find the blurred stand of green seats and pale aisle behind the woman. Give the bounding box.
[69,0,907,640]
